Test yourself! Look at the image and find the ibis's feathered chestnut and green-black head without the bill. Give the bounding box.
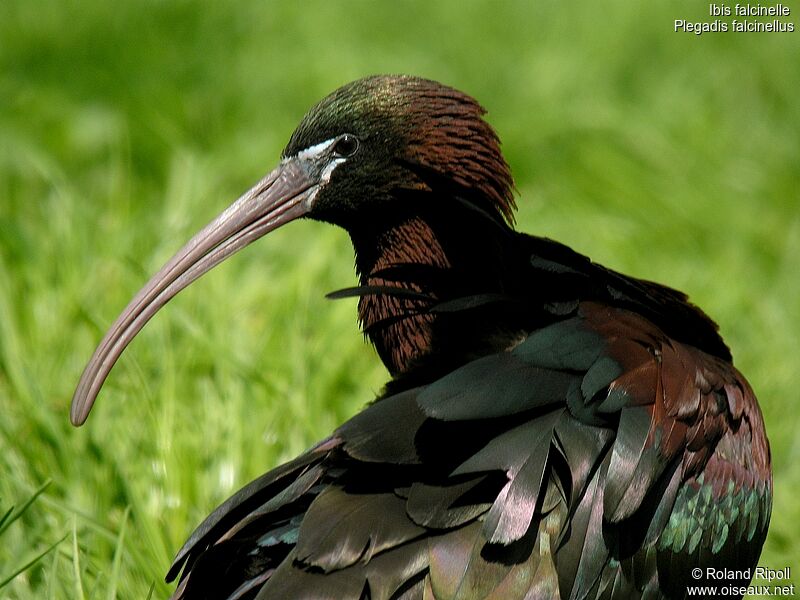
[283,75,514,229]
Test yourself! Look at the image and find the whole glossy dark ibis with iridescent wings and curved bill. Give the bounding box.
[70,75,773,600]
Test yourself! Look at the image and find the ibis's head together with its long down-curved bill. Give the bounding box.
[70,76,514,425]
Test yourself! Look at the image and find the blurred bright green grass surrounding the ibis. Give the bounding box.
[0,0,800,599]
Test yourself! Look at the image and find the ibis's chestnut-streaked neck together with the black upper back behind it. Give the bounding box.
[350,208,730,385]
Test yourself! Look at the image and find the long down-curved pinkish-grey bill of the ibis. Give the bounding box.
[70,159,319,425]
